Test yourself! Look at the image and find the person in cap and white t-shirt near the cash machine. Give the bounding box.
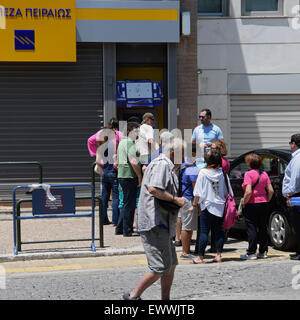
[137,112,156,164]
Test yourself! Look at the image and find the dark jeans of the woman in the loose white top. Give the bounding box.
[198,209,224,257]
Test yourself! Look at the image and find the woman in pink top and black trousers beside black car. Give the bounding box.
[241,153,274,260]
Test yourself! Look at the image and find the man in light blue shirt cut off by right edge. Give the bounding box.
[282,133,300,260]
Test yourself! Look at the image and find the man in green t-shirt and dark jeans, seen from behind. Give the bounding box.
[115,122,142,237]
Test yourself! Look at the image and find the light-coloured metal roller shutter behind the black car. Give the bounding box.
[230,95,300,156]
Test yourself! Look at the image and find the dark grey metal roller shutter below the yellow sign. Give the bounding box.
[0,44,103,198]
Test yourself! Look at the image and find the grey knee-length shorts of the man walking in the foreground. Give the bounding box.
[140,227,178,274]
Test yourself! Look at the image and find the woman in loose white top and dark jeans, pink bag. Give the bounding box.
[190,151,233,264]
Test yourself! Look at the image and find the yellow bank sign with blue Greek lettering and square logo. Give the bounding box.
[0,0,76,62]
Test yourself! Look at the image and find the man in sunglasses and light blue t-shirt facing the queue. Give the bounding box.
[192,109,224,162]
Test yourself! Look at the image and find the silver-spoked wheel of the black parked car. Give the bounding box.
[269,212,293,250]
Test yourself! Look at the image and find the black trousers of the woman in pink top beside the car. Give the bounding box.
[243,202,269,255]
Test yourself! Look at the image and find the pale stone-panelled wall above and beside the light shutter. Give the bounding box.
[197,0,300,154]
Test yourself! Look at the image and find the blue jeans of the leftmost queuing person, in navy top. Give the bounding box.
[102,171,119,224]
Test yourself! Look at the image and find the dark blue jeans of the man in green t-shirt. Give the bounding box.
[116,178,138,235]
